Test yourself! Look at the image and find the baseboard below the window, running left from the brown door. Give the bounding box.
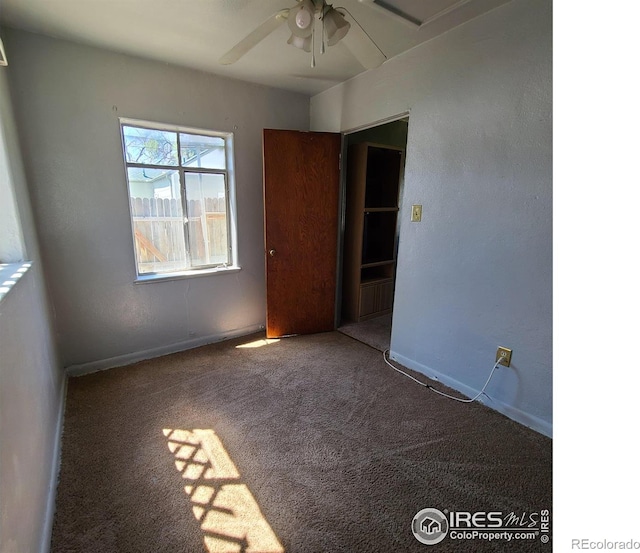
[66,324,264,376]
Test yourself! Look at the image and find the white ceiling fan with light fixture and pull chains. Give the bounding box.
[219,0,387,69]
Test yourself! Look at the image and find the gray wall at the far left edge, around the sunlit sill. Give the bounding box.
[0,63,66,553]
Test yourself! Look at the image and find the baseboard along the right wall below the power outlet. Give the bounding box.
[389,351,553,438]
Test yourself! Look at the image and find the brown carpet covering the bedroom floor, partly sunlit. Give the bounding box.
[52,332,552,553]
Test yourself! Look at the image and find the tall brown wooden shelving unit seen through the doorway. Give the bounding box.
[342,142,404,322]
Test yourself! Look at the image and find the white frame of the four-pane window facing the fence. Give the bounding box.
[118,117,240,283]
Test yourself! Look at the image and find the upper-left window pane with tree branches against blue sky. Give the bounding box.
[122,125,178,166]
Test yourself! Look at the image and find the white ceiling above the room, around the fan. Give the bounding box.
[0,0,509,95]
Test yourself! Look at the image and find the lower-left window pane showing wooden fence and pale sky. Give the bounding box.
[127,167,187,274]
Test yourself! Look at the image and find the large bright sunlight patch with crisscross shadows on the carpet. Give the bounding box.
[162,426,284,553]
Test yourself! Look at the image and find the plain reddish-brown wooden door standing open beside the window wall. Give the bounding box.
[263,129,341,338]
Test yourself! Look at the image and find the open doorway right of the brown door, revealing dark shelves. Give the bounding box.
[337,116,409,351]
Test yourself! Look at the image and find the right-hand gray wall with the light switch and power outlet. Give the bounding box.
[311,0,552,434]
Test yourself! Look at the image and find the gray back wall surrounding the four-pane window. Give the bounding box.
[4,29,309,372]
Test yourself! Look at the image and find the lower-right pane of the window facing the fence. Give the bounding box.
[185,173,230,267]
